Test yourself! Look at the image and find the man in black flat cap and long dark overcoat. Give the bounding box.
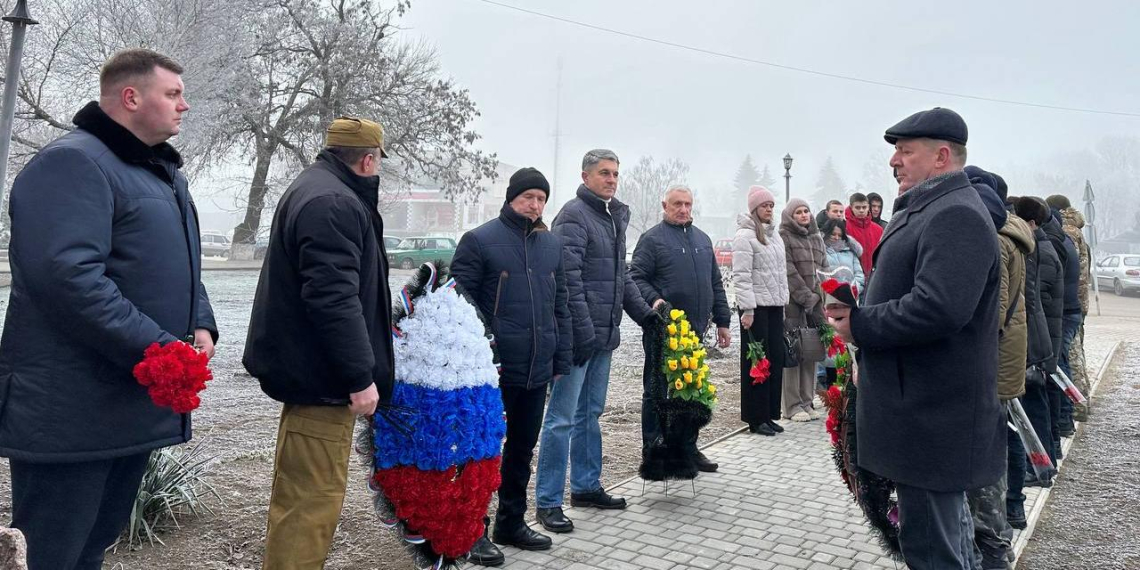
[828,108,1005,570]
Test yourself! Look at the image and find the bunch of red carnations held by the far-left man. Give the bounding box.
[135,341,213,414]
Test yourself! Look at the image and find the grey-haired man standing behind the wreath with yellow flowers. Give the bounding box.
[629,185,732,473]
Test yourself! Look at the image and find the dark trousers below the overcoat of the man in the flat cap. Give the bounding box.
[896,483,974,570]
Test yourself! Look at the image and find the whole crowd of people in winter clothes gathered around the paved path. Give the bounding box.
[0,49,1089,570]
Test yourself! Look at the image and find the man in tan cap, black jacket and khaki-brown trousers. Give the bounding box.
[242,117,396,570]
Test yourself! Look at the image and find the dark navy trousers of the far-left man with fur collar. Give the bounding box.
[9,451,150,570]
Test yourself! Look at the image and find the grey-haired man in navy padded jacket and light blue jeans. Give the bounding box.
[535,149,663,532]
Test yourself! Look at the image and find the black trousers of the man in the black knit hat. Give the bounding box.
[495,381,557,534]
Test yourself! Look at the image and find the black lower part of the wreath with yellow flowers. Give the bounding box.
[637,303,713,481]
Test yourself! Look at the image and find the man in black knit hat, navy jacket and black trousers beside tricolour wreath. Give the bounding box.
[451,168,572,565]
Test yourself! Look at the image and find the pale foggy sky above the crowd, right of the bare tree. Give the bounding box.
[401,0,1140,212]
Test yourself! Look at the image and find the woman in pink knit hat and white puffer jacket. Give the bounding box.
[732,186,788,435]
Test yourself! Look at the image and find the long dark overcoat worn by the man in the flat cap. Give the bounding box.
[850,172,1005,492]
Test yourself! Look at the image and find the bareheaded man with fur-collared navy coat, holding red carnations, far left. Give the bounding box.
[0,49,218,570]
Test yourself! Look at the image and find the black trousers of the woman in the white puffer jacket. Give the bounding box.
[740,307,784,425]
